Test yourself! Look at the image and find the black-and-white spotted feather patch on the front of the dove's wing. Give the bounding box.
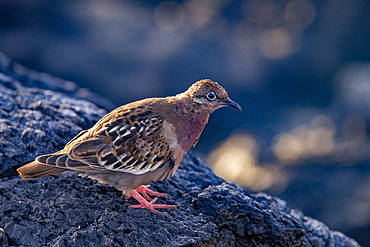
[97,110,172,175]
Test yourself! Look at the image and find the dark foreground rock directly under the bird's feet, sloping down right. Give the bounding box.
[0,154,358,246]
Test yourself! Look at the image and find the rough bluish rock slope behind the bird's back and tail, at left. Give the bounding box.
[0,53,106,177]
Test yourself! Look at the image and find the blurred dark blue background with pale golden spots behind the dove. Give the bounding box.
[0,0,370,246]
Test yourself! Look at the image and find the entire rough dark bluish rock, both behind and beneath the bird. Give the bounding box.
[0,53,358,246]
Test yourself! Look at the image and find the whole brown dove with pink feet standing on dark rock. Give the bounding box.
[17,79,242,215]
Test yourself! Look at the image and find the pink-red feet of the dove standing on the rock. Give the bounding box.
[126,186,178,215]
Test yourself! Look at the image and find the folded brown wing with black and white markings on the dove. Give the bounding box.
[36,107,173,175]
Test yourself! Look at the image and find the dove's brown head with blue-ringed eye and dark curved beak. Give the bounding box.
[185,79,242,113]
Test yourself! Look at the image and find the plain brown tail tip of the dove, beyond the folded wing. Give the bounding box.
[17,161,67,180]
